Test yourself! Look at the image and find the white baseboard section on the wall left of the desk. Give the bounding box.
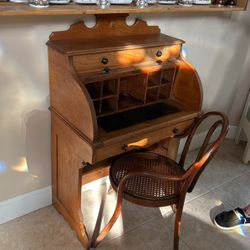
[0,186,52,224]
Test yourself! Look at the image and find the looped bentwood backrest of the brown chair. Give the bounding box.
[179,112,229,192]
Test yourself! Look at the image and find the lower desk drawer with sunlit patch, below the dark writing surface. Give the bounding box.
[94,120,193,162]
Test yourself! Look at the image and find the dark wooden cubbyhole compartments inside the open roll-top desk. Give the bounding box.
[85,66,176,117]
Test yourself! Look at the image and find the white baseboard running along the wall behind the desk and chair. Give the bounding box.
[0,126,238,224]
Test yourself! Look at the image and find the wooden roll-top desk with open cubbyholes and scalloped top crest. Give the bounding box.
[47,15,202,248]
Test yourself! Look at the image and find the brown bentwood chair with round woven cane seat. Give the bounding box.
[91,112,228,250]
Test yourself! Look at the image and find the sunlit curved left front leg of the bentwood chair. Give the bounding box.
[91,188,122,248]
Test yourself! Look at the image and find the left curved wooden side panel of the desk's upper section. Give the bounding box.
[49,49,97,141]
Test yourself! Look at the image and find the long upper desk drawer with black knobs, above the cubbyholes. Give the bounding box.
[73,45,181,73]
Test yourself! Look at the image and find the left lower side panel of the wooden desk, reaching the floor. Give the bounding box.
[52,125,89,249]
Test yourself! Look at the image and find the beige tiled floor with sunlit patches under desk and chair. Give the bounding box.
[0,140,250,250]
